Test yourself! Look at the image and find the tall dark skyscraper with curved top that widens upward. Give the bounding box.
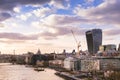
[86,29,102,54]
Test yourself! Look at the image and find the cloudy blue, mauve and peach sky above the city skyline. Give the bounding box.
[0,0,120,54]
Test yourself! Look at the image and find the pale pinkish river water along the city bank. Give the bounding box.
[0,63,64,80]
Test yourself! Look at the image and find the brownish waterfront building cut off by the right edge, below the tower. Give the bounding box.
[93,56,120,71]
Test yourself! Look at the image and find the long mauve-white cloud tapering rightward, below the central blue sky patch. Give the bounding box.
[41,14,89,26]
